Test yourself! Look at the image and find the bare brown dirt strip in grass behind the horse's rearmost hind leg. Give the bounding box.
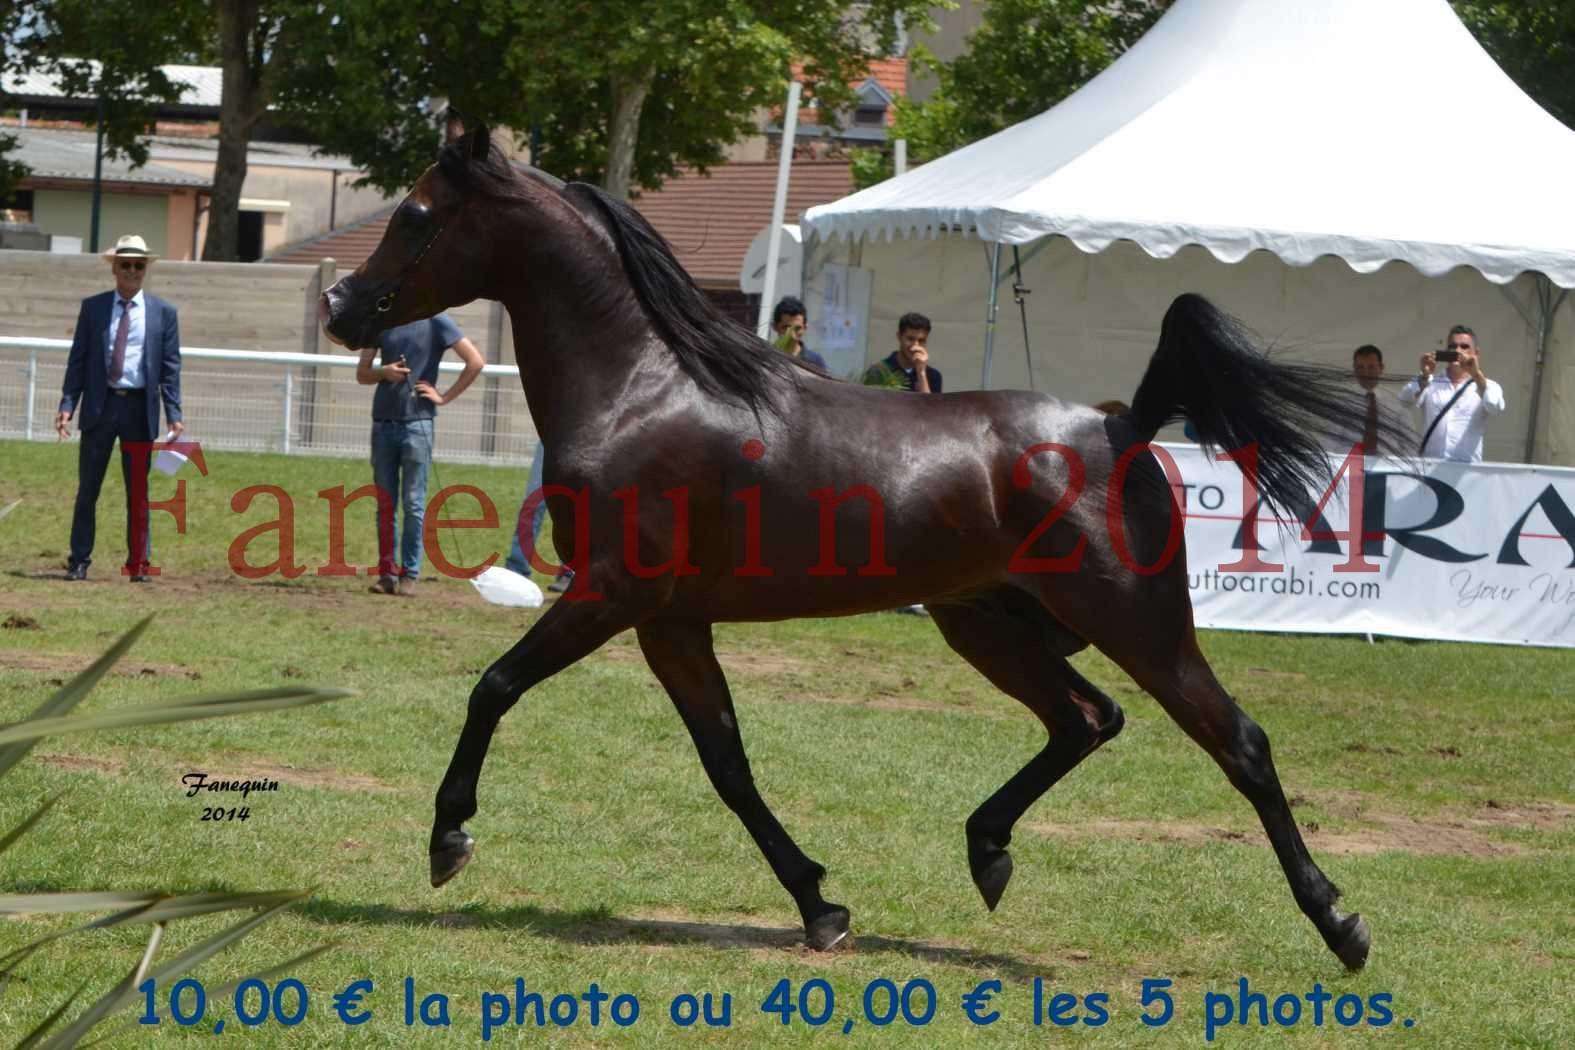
[1024,801,1575,856]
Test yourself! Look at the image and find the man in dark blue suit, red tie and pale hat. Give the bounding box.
[55,236,186,584]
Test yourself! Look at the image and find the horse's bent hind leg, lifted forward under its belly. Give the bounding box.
[929,587,1125,911]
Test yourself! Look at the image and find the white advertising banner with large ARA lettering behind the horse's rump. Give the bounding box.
[1156,444,1575,647]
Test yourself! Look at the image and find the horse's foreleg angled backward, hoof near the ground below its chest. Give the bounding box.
[636,620,847,951]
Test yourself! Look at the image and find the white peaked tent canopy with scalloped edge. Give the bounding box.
[805,0,1575,288]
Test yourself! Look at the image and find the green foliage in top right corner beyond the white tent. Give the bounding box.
[1452,0,1575,128]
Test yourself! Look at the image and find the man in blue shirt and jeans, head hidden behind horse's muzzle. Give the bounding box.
[356,313,484,598]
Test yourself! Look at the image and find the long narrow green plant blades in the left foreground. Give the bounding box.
[0,617,348,1050]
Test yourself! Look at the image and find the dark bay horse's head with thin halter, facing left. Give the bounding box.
[318,126,509,348]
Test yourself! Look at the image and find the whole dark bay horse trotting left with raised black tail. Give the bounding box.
[321,129,1370,968]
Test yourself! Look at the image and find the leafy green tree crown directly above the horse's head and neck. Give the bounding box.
[280,0,928,197]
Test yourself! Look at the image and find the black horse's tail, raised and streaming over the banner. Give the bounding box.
[1128,294,1366,518]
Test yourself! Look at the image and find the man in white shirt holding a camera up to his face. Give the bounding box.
[1400,324,1504,463]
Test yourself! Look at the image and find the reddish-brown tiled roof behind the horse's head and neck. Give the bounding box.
[268,161,852,288]
